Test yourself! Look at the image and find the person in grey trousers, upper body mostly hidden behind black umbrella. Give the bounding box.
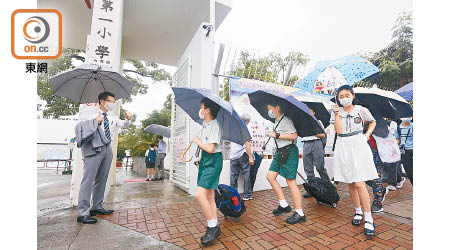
[302,108,330,198]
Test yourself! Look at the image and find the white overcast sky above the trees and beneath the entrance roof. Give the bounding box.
[124,0,412,123]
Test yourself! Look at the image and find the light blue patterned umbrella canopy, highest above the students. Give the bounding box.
[294,55,380,92]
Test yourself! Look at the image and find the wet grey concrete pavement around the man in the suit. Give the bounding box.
[37,170,181,250]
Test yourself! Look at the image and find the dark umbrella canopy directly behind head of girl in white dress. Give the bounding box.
[332,86,413,119]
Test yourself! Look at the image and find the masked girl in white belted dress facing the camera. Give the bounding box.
[330,85,378,238]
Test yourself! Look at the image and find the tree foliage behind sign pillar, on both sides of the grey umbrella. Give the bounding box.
[37,48,171,119]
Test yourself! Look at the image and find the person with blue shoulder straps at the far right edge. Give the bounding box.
[395,117,413,184]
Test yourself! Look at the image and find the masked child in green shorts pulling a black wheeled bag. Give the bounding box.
[266,101,306,224]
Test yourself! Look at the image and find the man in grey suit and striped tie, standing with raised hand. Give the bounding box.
[75,92,131,224]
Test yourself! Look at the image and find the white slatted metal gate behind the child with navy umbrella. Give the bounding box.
[170,56,192,189]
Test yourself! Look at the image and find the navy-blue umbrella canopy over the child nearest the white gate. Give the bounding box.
[172,87,251,145]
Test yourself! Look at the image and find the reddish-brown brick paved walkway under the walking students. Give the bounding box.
[99,182,413,249]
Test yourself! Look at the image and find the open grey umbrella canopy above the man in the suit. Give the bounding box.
[50,64,135,103]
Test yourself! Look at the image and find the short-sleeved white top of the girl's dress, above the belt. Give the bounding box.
[330,105,375,134]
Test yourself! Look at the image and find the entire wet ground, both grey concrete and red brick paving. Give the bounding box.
[37,169,413,249]
